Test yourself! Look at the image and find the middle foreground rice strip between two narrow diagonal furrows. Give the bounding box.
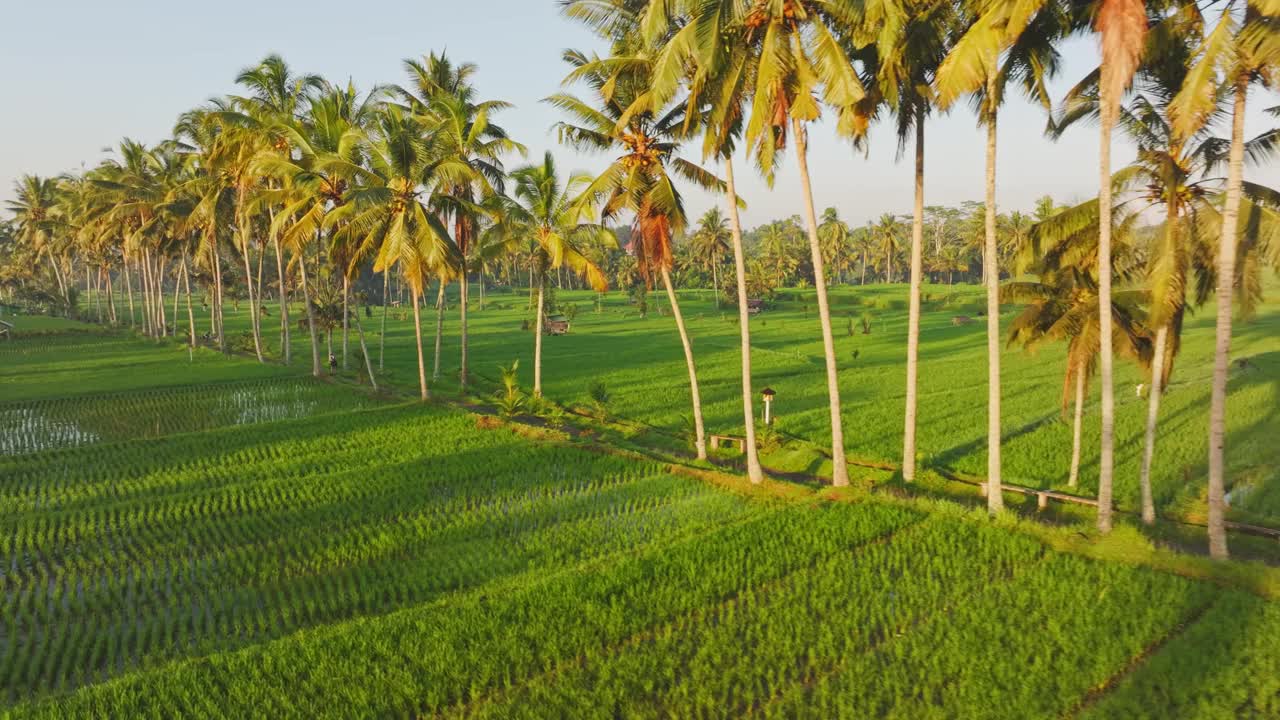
[457,516,1043,717]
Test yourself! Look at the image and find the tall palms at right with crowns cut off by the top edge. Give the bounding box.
[562,0,1280,557]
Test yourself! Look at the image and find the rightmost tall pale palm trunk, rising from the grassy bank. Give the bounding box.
[1208,73,1249,560]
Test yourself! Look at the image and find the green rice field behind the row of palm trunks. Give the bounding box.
[62,274,1280,521]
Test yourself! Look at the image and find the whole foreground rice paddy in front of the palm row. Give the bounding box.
[0,327,1280,719]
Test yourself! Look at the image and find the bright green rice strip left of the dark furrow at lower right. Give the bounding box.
[765,545,1217,717]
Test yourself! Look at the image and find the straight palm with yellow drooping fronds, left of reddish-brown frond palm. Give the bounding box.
[934,0,1068,514]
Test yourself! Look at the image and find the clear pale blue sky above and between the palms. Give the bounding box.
[0,0,1280,227]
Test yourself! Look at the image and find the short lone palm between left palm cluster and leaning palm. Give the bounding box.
[486,151,617,397]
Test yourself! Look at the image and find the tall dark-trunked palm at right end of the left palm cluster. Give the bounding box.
[396,53,525,389]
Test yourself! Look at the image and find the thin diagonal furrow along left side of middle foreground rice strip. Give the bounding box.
[443,515,928,717]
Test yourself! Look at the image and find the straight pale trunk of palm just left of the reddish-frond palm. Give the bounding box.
[982,102,1005,515]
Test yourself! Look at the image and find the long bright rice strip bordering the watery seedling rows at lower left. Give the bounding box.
[5,493,919,716]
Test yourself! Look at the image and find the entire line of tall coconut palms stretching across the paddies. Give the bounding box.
[10,0,1280,557]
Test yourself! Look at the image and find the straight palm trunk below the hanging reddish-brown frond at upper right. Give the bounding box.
[1098,97,1116,533]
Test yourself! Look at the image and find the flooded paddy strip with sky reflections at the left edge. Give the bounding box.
[0,379,364,455]
